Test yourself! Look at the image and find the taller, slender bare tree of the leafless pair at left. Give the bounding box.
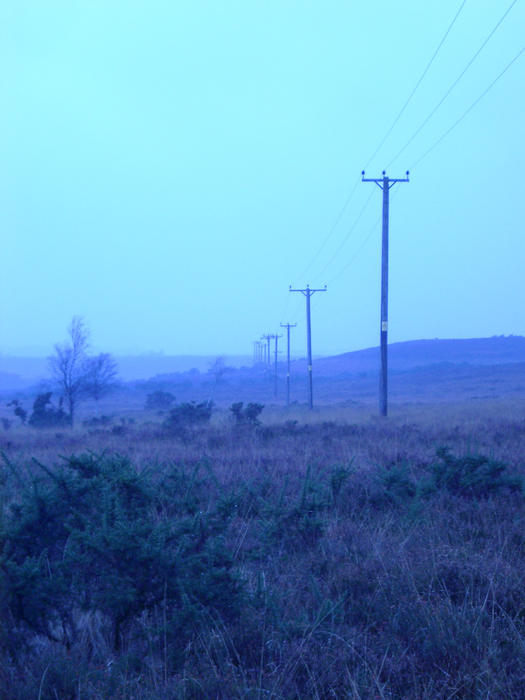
[49,316,89,425]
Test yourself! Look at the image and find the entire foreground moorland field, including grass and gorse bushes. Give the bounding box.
[0,398,525,700]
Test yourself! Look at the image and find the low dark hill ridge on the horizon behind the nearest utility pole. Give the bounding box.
[294,335,525,376]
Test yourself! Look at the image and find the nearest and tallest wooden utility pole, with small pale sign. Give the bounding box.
[361,170,409,416]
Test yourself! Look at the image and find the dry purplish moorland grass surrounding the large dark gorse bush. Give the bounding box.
[0,399,525,700]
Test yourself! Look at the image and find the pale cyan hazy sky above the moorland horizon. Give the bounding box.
[0,0,525,355]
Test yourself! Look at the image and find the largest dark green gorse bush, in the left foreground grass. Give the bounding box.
[0,455,241,649]
